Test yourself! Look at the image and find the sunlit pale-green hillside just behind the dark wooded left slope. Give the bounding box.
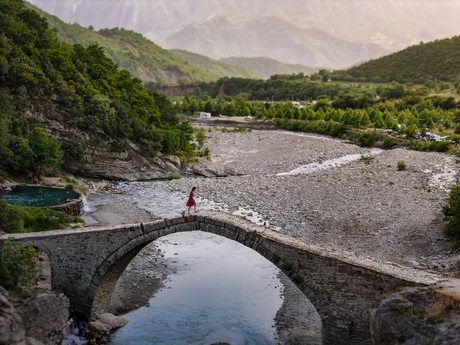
[26,3,218,83]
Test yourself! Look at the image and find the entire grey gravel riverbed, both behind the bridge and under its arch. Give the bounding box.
[82,128,460,343]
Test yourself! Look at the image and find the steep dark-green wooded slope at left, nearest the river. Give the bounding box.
[0,0,191,175]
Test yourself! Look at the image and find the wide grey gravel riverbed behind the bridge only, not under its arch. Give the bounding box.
[160,126,460,274]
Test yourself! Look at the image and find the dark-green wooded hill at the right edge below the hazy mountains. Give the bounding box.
[331,36,460,84]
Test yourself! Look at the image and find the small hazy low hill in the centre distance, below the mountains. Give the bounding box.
[220,57,318,79]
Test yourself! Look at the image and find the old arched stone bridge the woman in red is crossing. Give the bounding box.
[0,211,440,345]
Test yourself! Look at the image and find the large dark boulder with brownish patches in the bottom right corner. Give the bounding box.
[370,288,460,345]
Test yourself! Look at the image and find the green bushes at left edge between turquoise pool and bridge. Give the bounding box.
[0,200,83,234]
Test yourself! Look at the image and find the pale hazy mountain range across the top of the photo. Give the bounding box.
[32,0,460,68]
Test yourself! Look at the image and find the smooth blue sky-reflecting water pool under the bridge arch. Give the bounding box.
[112,231,283,345]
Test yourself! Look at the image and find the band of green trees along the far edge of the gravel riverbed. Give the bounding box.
[174,76,460,153]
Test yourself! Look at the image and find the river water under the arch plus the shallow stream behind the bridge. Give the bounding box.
[83,181,321,345]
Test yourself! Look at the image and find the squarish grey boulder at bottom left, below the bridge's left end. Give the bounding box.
[15,294,69,345]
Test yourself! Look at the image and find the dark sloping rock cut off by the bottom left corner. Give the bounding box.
[0,286,26,345]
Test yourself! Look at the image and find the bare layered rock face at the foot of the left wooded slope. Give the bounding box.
[27,112,180,181]
